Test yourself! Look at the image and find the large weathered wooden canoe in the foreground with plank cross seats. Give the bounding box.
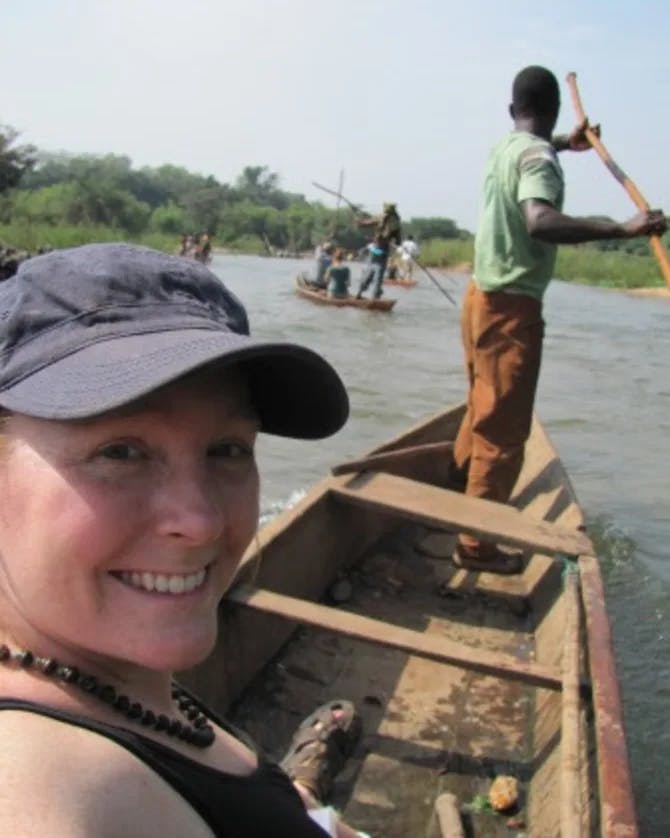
[187,407,638,838]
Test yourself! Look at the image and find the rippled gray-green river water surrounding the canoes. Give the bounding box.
[212,254,670,836]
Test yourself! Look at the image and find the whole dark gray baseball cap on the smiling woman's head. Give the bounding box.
[0,244,349,439]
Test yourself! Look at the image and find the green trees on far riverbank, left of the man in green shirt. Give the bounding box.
[0,127,470,252]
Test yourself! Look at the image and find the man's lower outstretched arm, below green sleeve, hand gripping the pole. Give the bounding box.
[521,199,668,244]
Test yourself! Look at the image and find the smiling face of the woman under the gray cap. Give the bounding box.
[0,370,258,670]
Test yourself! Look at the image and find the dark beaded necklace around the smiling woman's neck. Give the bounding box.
[0,643,216,748]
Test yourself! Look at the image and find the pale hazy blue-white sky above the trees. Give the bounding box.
[0,0,670,229]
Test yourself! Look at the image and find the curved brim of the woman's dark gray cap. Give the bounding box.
[0,329,349,439]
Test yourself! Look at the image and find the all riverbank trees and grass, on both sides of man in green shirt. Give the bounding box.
[0,126,668,287]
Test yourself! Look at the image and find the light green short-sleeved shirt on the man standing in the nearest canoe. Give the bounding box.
[474,131,564,300]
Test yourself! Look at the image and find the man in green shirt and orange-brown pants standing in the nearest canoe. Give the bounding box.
[452,67,666,573]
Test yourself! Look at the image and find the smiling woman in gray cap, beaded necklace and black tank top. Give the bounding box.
[0,245,362,838]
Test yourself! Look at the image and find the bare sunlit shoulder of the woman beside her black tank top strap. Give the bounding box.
[0,710,212,838]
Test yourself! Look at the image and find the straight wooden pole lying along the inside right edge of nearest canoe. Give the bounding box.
[561,566,582,838]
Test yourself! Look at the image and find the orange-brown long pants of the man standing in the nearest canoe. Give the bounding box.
[454,281,544,557]
